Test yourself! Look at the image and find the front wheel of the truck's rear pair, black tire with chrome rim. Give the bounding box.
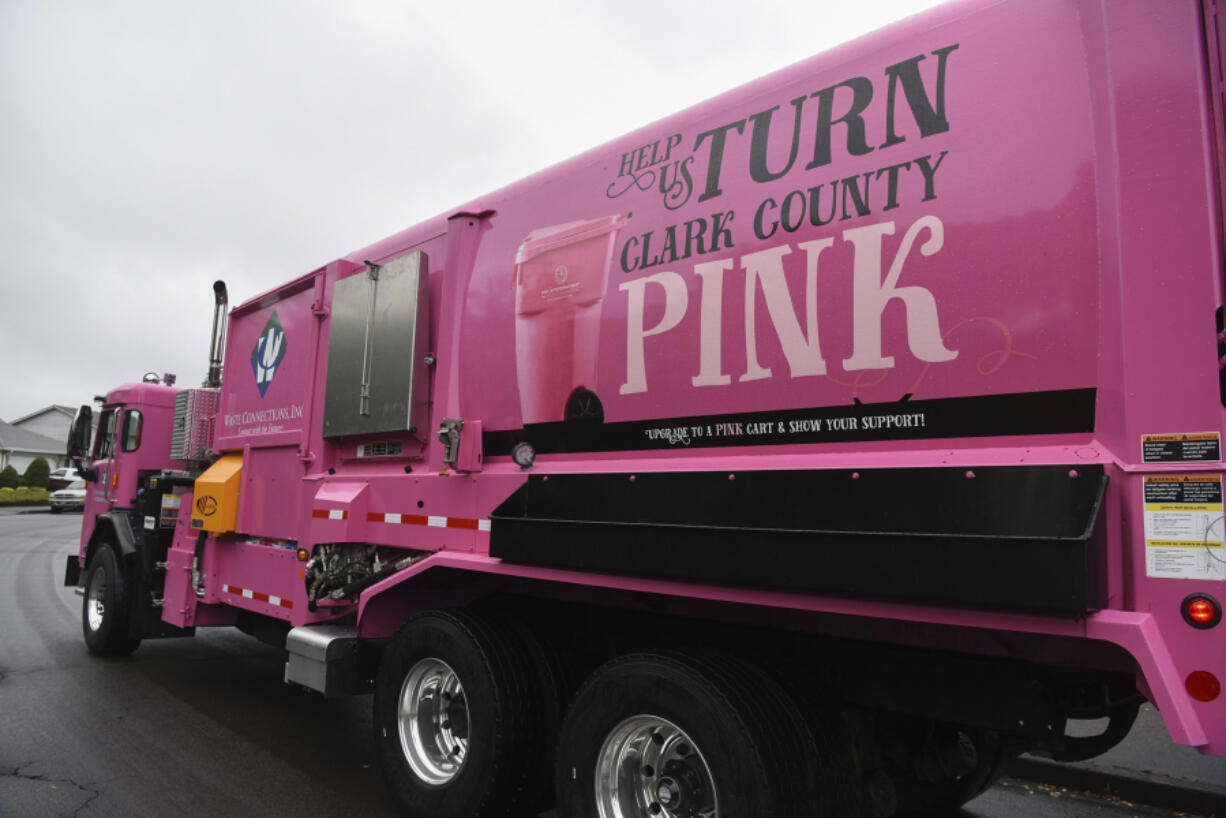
[374,611,560,818]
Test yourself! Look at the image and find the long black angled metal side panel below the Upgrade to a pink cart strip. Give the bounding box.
[490,465,1107,617]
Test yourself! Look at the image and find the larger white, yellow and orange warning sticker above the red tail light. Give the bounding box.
[1145,475,1226,581]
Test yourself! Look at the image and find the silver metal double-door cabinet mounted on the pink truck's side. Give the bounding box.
[324,253,430,438]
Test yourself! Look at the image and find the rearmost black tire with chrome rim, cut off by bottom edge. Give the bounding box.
[555,652,826,818]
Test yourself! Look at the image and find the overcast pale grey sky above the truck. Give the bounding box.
[0,0,935,421]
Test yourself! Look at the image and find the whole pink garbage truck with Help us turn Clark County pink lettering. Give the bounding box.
[65,0,1226,818]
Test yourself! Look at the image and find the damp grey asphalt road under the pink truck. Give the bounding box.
[0,514,1211,818]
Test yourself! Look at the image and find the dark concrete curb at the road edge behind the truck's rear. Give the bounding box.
[1003,757,1226,818]
